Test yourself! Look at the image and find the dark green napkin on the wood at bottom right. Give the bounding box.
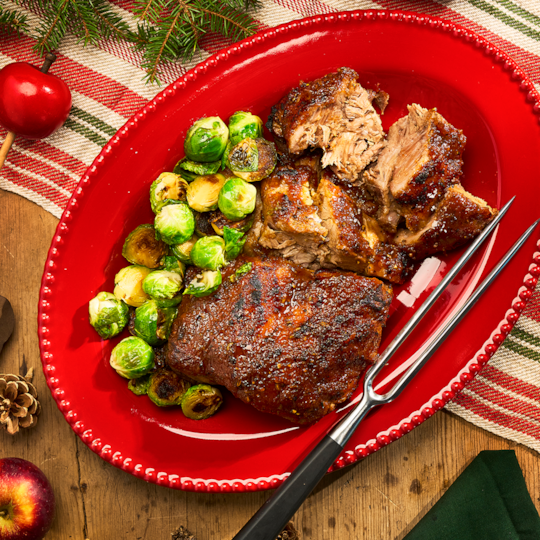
[403,450,540,540]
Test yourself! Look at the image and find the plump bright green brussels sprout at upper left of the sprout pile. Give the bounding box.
[184,116,229,163]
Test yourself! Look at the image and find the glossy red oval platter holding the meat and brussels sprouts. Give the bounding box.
[39,11,540,492]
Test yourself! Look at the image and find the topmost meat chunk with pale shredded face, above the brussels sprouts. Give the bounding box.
[270,68,388,181]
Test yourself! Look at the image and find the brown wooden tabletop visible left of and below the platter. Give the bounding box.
[0,190,540,540]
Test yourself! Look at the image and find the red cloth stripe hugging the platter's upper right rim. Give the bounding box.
[377,0,540,83]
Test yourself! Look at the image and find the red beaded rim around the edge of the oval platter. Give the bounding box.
[38,10,540,493]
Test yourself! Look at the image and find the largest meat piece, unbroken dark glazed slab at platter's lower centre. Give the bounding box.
[167,257,392,424]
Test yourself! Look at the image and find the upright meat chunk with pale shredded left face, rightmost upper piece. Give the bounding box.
[364,104,466,231]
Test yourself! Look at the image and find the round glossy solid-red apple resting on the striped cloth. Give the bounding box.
[0,62,71,139]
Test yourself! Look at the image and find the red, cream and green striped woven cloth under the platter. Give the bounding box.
[0,0,540,451]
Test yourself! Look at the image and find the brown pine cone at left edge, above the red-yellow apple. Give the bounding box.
[0,370,41,435]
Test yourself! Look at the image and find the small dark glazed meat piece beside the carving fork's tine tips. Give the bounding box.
[395,185,498,259]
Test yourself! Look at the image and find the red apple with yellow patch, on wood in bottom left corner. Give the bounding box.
[0,458,55,540]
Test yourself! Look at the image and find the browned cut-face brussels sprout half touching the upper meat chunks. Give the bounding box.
[227,137,277,182]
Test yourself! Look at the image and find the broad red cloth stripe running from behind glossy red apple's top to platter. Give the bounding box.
[0,34,147,118]
